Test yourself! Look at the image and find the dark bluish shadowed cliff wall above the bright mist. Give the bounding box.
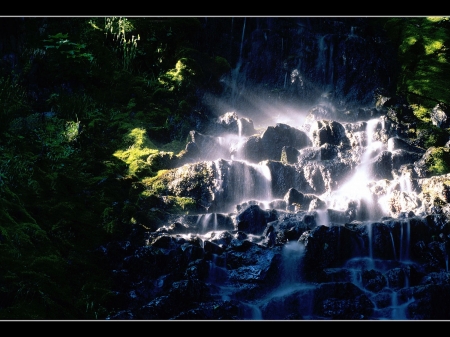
[212,18,397,119]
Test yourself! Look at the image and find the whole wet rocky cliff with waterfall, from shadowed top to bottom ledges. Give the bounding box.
[95,18,450,320]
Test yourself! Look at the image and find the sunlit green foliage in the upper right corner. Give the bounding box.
[385,17,450,116]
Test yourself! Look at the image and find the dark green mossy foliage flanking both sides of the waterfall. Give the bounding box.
[0,17,450,319]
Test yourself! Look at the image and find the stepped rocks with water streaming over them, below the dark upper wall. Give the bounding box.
[99,103,450,320]
